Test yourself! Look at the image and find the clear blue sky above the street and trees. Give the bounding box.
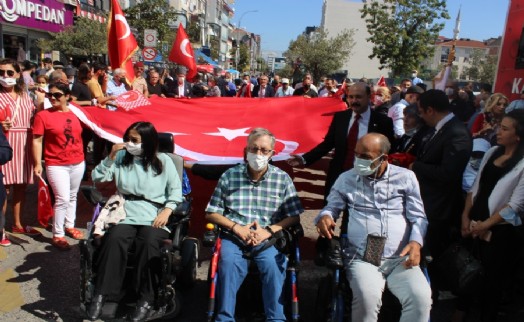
[233,0,510,51]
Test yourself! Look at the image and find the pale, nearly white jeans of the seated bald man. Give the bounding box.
[346,256,431,322]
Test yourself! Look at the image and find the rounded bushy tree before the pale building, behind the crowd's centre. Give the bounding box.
[283,28,355,80]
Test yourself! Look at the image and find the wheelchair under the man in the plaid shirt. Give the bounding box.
[202,223,304,322]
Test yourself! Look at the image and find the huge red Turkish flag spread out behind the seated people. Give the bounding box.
[70,96,347,164]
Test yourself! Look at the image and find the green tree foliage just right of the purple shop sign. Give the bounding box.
[38,17,107,56]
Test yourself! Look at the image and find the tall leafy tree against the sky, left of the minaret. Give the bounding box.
[361,0,449,77]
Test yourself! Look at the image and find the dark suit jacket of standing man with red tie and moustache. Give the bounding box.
[303,110,394,196]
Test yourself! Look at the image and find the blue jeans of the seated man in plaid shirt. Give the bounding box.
[215,237,287,322]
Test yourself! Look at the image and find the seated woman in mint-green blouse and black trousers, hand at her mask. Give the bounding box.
[87,122,182,321]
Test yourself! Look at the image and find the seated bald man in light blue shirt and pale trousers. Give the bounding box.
[315,133,431,322]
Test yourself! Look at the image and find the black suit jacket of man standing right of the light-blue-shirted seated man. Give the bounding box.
[413,116,473,226]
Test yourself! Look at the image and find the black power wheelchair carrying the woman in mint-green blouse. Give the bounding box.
[79,133,200,321]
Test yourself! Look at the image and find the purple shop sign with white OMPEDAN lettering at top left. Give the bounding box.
[0,0,73,32]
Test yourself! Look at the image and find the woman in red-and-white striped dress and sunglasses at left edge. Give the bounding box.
[0,59,40,235]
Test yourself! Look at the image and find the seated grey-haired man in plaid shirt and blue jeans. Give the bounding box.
[206,128,303,322]
